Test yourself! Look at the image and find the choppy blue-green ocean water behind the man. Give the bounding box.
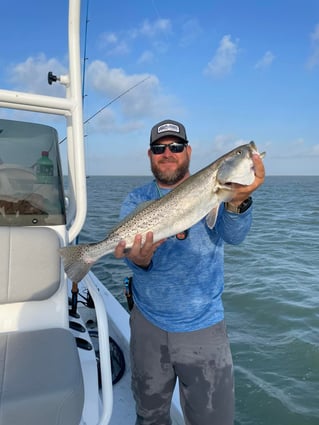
[80,176,319,425]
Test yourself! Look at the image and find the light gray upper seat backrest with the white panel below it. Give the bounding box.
[0,226,69,332]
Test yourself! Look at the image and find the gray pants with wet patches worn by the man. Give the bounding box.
[130,306,234,425]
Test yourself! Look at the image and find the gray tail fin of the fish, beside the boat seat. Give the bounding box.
[59,245,95,283]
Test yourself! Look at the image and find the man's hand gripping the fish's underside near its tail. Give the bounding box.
[114,232,165,268]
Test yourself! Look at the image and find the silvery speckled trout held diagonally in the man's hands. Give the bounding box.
[60,142,264,282]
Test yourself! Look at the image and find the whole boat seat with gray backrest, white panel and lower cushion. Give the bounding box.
[0,226,84,425]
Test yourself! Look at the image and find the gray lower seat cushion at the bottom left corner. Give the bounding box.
[0,328,84,425]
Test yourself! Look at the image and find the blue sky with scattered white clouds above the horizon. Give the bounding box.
[0,0,319,175]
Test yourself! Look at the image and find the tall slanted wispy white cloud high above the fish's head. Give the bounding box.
[204,35,239,77]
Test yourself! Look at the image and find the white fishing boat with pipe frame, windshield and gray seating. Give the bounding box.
[0,0,184,425]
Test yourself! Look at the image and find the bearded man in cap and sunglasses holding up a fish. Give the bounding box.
[115,120,265,425]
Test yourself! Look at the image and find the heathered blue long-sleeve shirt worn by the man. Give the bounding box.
[120,181,252,332]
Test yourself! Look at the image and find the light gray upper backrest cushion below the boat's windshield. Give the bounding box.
[0,227,61,304]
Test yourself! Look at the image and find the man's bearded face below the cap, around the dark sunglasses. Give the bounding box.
[148,136,192,186]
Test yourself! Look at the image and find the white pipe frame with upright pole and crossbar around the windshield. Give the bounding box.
[0,0,87,242]
